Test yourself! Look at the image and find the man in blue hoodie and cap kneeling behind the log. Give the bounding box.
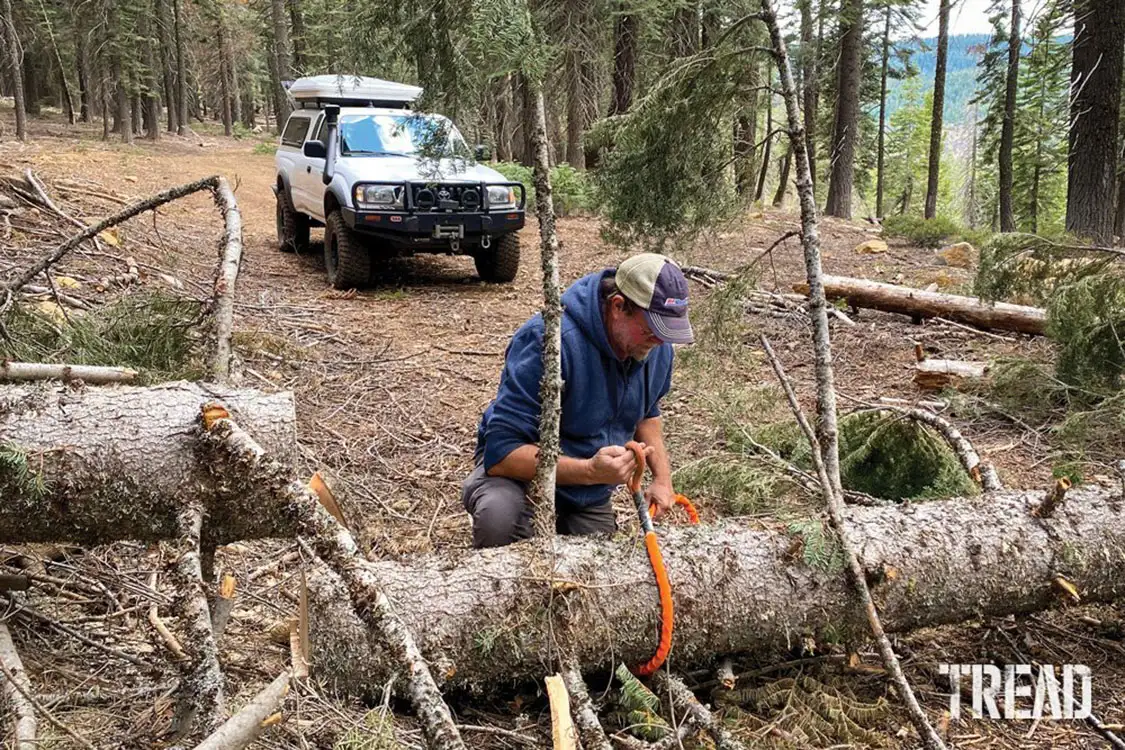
[461,253,694,548]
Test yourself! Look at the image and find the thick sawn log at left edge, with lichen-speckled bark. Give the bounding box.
[0,382,297,546]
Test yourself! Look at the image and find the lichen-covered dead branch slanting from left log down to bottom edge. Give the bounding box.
[203,404,465,750]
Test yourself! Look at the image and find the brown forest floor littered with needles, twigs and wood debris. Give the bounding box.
[0,108,1125,748]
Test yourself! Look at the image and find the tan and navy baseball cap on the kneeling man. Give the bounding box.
[614,253,695,344]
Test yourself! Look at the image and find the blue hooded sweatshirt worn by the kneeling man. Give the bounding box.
[477,269,673,507]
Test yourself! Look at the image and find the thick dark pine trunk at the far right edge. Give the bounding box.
[1067,0,1125,244]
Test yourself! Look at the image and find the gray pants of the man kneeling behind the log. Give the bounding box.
[461,463,618,549]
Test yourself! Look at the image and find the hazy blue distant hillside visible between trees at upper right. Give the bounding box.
[887,34,990,127]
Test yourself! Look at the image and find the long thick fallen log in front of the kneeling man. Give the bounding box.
[311,486,1125,695]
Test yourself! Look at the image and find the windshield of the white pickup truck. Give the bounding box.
[340,115,471,159]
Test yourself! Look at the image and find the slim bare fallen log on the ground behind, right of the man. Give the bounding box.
[793,275,1047,335]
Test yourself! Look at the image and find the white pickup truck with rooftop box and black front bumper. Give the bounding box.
[273,75,527,289]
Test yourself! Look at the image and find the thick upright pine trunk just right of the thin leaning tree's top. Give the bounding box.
[825,0,859,219]
